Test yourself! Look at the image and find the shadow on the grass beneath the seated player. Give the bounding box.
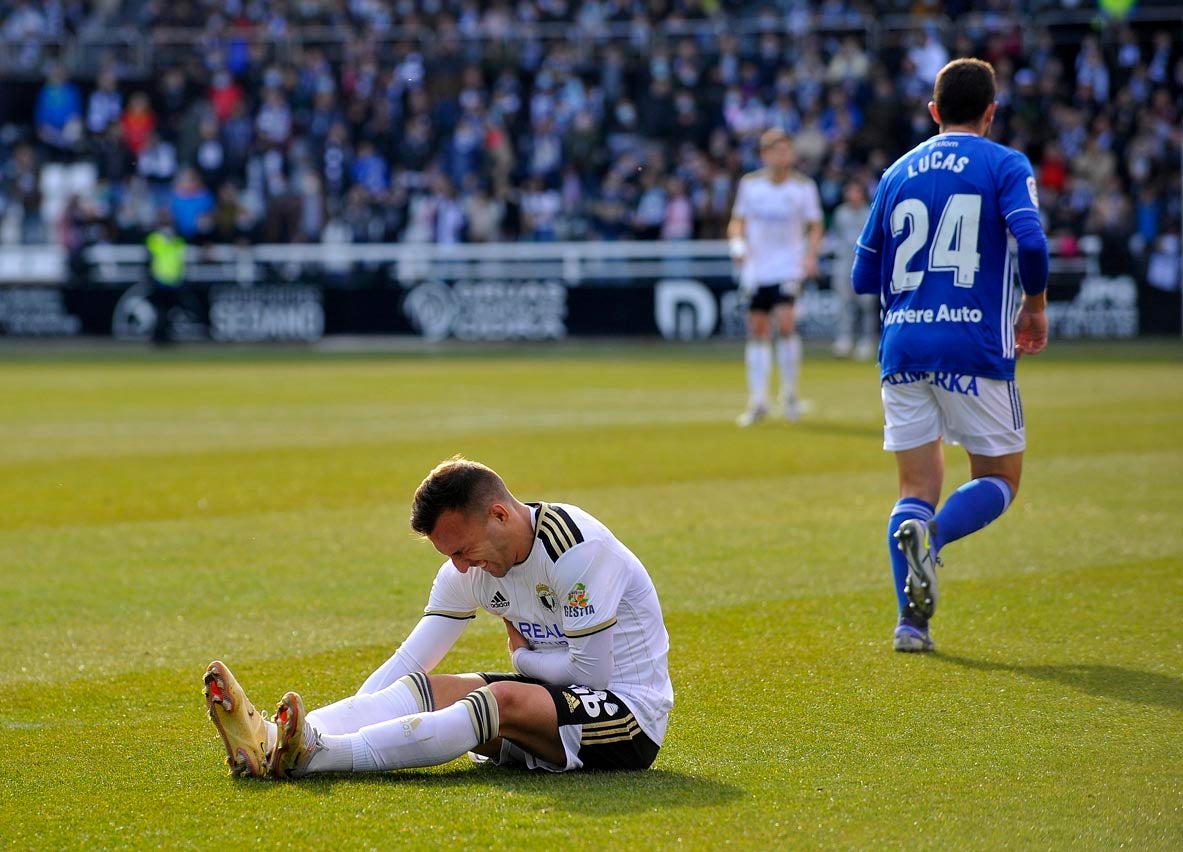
[291,762,744,814]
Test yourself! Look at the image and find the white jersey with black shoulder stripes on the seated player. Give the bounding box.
[424,503,673,744]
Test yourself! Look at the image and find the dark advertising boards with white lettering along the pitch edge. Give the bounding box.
[0,269,1164,342]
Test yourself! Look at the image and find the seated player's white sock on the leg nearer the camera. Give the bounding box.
[308,686,500,773]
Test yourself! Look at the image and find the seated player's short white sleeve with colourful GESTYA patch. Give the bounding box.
[555,541,628,639]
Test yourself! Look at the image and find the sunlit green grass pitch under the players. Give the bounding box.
[0,342,1183,850]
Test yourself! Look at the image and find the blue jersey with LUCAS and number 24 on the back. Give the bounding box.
[855,133,1039,380]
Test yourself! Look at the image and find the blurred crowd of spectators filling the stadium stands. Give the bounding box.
[0,0,1183,273]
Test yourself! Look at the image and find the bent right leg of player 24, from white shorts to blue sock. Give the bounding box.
[933,379,1027,553]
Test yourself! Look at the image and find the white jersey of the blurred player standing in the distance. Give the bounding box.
[732,169,822,290]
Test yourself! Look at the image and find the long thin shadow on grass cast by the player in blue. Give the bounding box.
[933,654,1183,710]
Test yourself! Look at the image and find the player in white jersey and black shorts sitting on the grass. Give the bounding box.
[203,457,673,779]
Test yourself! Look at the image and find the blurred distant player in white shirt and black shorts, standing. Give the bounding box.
[728,129,825,426]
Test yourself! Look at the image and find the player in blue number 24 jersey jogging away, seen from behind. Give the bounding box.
[852,59,1048,651]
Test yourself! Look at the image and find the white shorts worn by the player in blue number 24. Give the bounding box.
[881,373,1027,457]
